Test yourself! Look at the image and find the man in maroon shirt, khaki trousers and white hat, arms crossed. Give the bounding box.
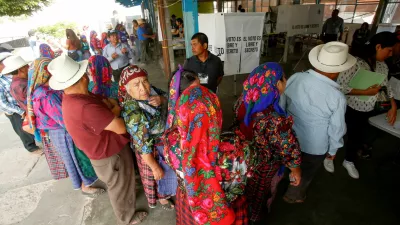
[48,55,147,225]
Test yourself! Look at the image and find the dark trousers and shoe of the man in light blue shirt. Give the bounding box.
[285,152,325,200]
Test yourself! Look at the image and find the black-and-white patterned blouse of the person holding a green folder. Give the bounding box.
[337,58,393,112]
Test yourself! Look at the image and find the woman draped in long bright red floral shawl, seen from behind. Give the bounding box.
[164,69,235,225]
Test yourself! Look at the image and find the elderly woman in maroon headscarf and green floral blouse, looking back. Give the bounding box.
[119,66,177,210]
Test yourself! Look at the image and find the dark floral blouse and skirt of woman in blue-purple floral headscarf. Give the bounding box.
[236,99,301,221]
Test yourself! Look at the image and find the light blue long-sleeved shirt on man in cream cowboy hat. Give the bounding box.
[279,70,346,155]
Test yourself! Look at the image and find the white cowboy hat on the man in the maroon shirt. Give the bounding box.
[47,55,88,90]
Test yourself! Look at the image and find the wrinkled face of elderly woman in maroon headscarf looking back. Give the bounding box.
[125,77,150,100]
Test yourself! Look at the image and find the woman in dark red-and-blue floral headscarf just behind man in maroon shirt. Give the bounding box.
[87,55,118,99]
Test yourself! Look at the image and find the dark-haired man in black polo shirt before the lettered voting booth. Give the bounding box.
[183,33,224,93]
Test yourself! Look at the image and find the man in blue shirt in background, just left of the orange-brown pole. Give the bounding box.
[137,19,155,64]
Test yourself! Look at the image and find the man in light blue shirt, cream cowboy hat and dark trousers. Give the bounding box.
[281,41,357,203]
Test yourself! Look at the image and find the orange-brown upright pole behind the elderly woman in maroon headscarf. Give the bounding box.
[158,0,171,78]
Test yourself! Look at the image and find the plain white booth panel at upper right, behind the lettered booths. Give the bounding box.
[276,4,324,37]
